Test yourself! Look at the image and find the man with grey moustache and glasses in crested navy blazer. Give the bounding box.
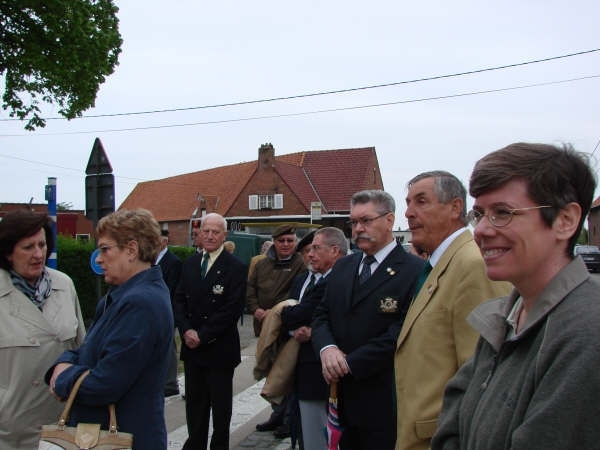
[311,190,424,450]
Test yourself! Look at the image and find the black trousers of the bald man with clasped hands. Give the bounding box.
[183,363,234,450]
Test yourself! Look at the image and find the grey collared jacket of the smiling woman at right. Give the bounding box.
[431,258,600,450]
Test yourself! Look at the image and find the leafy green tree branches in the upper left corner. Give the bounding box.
[0,0,123,130]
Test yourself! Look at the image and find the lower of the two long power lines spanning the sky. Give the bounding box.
[0,74,600,138]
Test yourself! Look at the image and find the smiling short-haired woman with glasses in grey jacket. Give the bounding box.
[431,143,600,450]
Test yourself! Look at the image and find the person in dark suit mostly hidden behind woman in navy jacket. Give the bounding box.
[156,230,181,397]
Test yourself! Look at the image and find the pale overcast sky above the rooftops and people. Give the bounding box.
[0,0,600,227]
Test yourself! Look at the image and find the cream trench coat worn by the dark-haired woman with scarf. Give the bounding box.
[0,269,85,450]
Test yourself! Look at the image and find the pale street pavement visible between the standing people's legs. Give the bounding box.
[165,315,291,450]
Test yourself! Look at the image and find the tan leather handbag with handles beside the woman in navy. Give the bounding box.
[38,370,133,450]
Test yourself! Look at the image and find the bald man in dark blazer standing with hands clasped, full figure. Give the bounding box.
[175,213,248,450]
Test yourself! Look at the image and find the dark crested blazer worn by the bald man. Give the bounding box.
[174,250,248,368]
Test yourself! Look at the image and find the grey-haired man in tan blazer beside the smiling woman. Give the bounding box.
[394,171,510,450]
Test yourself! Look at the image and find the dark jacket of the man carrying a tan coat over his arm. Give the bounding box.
[281,275,329,401]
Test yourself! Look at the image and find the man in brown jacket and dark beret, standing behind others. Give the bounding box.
[246,224,306,431]
